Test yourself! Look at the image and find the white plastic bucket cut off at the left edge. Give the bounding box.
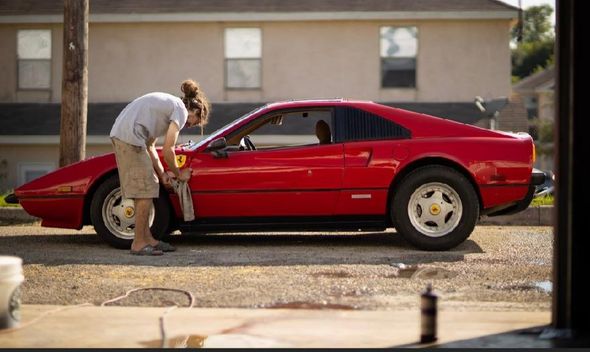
[0,255,25,329]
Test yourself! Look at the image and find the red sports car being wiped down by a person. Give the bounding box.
[9,99,545,250]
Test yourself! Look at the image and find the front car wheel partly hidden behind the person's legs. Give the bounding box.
[90,175,172,249]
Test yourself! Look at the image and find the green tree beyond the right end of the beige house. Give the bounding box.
[512,5,555,79]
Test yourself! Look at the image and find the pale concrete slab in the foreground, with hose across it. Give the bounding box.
[0,305,552,348]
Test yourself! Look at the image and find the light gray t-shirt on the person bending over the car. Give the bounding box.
[110,92,188,148]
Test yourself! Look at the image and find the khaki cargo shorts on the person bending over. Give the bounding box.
[111,138,160,199]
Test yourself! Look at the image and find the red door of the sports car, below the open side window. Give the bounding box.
[191,108,344,218]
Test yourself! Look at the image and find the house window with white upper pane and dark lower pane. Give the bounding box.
[380,27,418,88]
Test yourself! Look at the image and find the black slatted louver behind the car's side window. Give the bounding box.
[335,107,411,142]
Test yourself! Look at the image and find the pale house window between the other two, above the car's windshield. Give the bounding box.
[225,28,262,88]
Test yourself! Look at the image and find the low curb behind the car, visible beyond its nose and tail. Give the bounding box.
[0,206,553,226]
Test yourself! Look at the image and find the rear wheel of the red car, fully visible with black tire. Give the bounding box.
[390,165,479,251]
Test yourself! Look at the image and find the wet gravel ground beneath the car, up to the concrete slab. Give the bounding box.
[0,224,553,311]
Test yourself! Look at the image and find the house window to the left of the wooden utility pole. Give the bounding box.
[16,29,51,90]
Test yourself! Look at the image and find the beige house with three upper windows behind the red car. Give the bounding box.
[0,0,520,190]
